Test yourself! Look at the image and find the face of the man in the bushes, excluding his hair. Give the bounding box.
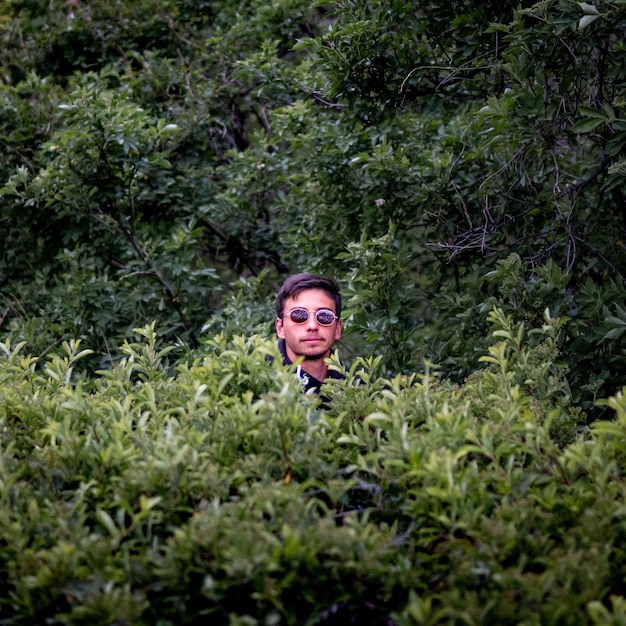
[276,289,341,361]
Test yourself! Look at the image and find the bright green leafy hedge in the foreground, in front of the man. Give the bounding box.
[0,320,626,626]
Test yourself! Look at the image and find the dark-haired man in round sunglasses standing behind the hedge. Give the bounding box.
[276,273,343,393]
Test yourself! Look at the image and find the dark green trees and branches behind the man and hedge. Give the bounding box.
[0,0,626,400]
